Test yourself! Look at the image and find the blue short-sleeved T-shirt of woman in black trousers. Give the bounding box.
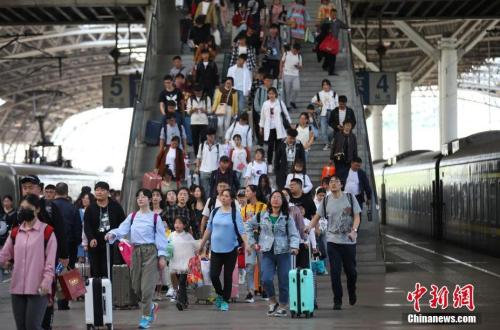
[207,208,245,253]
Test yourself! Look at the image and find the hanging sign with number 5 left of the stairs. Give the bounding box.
[102,75,130,108]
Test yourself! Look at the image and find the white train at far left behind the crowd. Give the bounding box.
[0,163,106,205]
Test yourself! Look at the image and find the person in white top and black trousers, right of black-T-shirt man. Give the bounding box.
[186,84,212,155]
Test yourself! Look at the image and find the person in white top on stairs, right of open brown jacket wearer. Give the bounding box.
[194,128,223,196]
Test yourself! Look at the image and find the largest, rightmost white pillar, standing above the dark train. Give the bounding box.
[438,38,458,145]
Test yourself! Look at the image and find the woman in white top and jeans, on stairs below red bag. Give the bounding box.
[311,79,339,150]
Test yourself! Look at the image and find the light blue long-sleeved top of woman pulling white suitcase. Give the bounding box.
[109,211,168,257]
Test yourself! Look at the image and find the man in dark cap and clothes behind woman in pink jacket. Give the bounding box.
[20,174,69,330]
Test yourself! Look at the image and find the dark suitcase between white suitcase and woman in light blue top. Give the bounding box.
[112,265,139,309]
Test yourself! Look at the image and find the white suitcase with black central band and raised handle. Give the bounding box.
[85,243,113,330]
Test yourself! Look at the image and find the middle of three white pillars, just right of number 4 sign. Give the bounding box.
[397,72,413,153]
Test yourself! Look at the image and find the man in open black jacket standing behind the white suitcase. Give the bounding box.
[83,181,125,277]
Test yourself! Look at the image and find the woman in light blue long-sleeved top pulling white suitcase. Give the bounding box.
[104,189,167,329]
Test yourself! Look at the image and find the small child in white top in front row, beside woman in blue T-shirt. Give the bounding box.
[169,217,199,311]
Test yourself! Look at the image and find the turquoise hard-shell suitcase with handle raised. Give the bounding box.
[288,256,314,318]
